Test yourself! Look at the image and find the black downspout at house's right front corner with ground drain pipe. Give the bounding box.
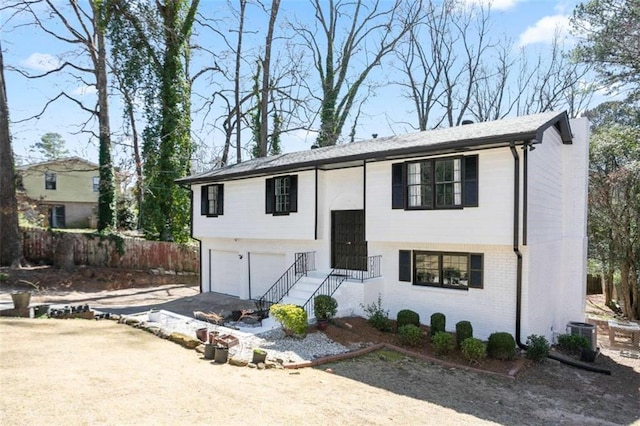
[509,142,611,375]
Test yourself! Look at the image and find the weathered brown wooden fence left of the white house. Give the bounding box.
[21,228,200,273]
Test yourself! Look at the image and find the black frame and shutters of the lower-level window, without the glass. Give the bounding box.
[398,250,484,291]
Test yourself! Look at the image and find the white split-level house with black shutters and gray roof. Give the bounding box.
[180,112,588,342]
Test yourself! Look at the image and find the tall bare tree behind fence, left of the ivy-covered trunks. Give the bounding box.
[4,0,116,230]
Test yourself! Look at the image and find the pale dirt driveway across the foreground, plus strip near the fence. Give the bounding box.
[0,270,640,425]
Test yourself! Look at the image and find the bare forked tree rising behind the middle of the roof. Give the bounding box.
[295,0,422,146]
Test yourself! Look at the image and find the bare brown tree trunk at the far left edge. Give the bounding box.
[0,40,22,267]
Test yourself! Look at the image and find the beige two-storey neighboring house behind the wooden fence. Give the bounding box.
[17,157,100,228]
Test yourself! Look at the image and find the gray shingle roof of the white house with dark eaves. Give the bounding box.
[177,112,571,183]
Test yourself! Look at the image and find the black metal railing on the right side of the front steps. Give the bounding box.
[303,255,382,318]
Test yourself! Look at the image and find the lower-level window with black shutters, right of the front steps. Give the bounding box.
[398,250,484,290]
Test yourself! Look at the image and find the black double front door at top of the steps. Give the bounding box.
[331,210,367,271]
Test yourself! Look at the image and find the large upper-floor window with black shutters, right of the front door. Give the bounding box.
[391,155,478,210]
